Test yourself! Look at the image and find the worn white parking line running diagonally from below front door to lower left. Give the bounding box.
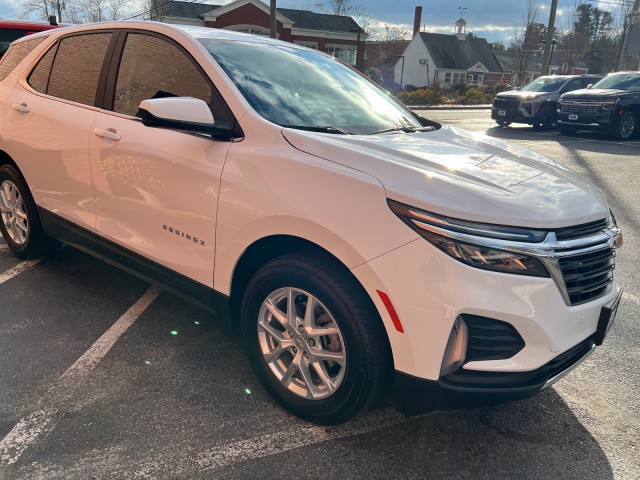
[0,284,160,466]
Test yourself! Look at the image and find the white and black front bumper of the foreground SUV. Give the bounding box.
[353,239,621,413]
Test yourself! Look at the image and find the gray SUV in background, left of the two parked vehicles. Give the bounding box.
[491,75,602,130]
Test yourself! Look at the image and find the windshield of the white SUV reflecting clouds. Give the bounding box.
[198,38,421,134]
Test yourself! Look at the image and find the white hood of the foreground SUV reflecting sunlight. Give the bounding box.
[282,127,609,229]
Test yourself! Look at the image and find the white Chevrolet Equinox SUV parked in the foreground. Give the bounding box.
[0,22,622,424]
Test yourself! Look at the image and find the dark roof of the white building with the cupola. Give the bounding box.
[419,32,502,72]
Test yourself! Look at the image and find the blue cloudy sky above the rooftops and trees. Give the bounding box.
[0,0,632,44]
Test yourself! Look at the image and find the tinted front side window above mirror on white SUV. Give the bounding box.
[113,33,215,116]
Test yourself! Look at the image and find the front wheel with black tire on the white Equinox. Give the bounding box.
[241,252,393,425]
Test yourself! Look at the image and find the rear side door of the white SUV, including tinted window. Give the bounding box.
[4,32,112,230]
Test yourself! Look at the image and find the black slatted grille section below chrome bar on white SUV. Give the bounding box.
[559,248,616,305]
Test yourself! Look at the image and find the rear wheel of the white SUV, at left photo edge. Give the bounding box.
[0,165,53,259]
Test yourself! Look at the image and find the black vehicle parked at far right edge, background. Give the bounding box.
[557,72,640,140]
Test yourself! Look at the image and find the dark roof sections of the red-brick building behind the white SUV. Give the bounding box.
[163,0,364,33]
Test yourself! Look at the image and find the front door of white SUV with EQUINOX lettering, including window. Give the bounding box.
[89,32,231,288]
